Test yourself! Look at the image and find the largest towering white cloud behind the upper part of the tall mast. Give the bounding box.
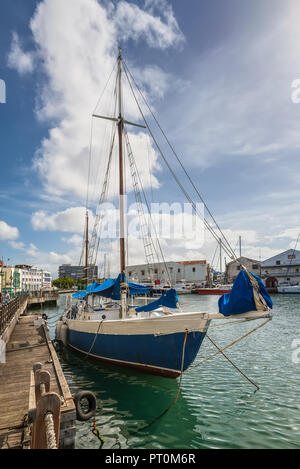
[14,0,183,202]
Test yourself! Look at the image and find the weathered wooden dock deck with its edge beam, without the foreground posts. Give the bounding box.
[0,298,76,449]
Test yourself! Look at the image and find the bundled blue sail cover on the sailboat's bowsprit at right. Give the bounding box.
[218,270,273,316]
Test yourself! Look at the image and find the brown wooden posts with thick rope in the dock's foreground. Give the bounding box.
[28,363,61,449]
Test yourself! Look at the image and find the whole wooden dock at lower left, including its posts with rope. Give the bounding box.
[0,295,91,449]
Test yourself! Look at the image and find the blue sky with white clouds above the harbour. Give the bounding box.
[0,0,300,277]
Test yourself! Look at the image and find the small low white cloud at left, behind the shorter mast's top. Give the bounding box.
[31,207,94,233]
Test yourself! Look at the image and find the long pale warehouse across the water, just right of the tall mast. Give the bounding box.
[126,260,208,285]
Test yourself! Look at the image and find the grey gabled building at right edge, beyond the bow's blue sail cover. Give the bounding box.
[261,249,300,288]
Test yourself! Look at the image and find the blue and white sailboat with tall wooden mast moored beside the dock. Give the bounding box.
[56,49,272,378]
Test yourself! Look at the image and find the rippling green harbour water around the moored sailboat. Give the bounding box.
[45,295,300,449]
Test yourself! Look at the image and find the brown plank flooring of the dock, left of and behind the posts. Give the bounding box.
[0,315,75,449]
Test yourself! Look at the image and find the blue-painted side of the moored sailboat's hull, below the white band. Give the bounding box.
[68,329,206,378]
